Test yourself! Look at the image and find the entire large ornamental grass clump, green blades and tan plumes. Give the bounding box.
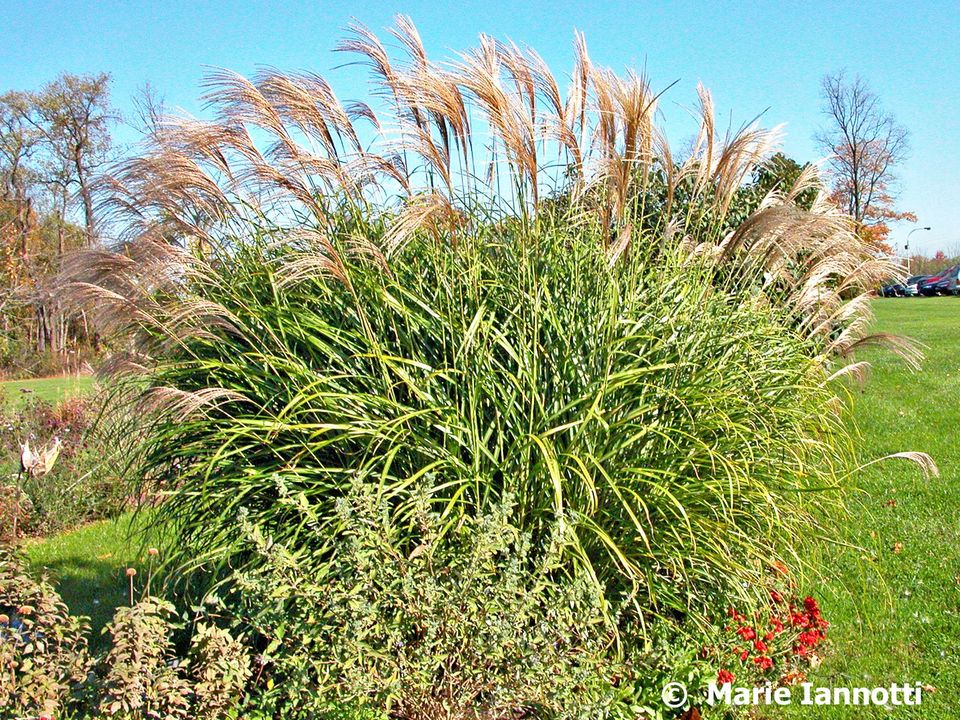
[58,19,924,717]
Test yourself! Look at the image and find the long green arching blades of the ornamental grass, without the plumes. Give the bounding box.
[114,228,845,609]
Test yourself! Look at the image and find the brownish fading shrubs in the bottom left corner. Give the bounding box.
[0,546,250,720]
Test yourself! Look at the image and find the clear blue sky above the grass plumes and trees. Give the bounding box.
[0,0,960,253]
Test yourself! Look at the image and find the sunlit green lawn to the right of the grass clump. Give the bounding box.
[772,298,960,720]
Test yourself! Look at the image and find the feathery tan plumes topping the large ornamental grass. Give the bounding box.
[92,18,898,374]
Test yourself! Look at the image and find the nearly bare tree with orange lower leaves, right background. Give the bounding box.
[816,72,916,250]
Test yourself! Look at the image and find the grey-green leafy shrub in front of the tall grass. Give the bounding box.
[243,488,623,720]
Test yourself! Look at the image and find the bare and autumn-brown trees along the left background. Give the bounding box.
[0,74,113,373]
